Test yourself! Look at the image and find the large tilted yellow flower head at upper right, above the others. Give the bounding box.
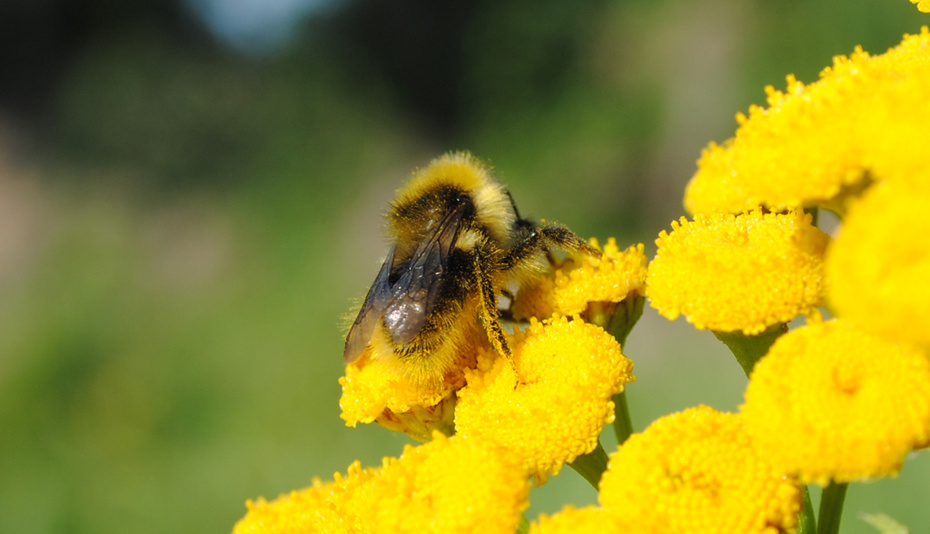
[685,28,930,214]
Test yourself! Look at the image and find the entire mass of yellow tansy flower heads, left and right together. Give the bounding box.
[235,11,930,534]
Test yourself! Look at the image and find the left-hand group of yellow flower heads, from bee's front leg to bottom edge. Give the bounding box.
[235,240,646,534]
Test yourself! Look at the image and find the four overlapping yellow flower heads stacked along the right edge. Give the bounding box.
[647,19,930,525]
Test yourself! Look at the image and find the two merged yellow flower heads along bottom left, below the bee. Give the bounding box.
[234,434,529,534]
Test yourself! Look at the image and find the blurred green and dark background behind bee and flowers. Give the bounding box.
[0,0,930,533]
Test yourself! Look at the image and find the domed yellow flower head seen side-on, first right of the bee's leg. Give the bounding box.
[646,210,829,335]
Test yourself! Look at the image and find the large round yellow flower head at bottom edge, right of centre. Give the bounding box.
[600,406,801,534]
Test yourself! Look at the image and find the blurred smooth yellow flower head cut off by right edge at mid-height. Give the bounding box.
[827,183,930,349]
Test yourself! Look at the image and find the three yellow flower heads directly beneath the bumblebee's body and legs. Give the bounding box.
[340,241,646,456]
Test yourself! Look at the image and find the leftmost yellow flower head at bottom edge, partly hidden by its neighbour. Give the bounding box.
[233,462,379,534]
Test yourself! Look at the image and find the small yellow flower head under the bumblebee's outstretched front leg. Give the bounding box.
[512,238,646,319]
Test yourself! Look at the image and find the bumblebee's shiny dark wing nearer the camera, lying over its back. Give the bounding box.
[384,204,465,345]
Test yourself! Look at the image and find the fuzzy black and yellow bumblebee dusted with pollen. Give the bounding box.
[343,153,600,380]
